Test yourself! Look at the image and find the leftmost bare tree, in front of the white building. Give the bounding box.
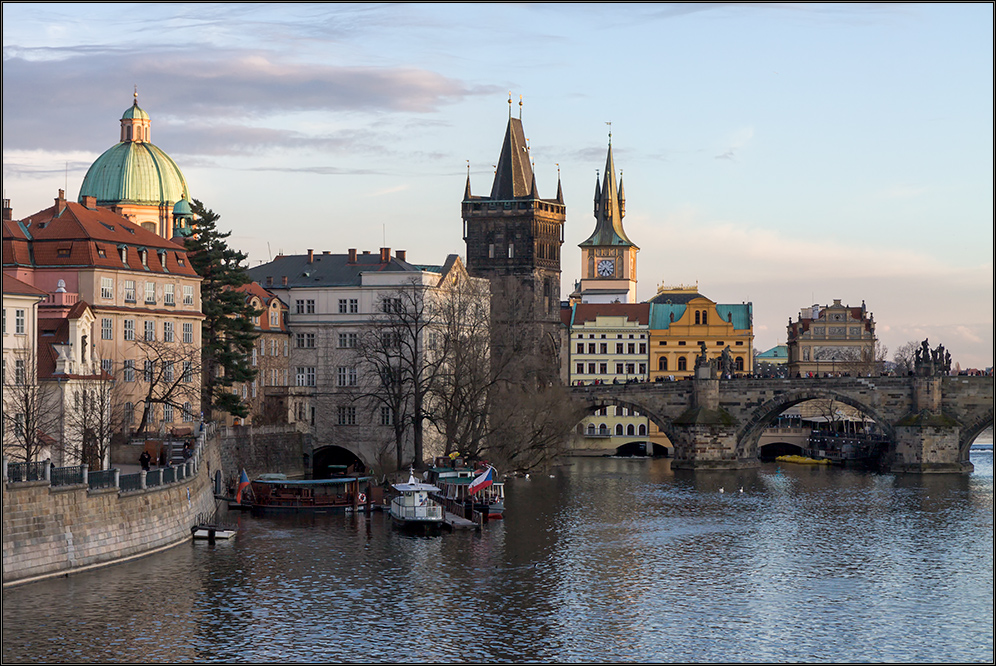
[3,349,61,462]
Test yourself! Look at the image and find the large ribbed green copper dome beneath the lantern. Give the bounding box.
[79,139,190,206]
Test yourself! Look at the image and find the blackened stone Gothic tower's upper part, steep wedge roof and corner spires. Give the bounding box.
[462,97,567,323]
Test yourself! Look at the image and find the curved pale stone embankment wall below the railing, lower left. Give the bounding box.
[2,430,224,586]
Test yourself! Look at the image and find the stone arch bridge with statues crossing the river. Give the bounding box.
[571,376,993,472]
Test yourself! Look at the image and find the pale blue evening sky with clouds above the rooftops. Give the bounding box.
[3,3,994,368]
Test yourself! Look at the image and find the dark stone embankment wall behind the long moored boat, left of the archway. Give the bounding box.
[218,425,311,486]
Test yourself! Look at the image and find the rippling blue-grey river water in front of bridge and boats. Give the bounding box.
[3,449,993,663]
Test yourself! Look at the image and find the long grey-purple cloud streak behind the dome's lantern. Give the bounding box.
[3,47,494,154]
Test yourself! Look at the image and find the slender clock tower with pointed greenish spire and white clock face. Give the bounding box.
[578,132,640,303]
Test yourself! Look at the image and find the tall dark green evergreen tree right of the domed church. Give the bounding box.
[185,199,262,418]
